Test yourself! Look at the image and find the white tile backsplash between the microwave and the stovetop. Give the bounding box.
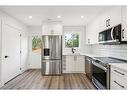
[91,45,127,60]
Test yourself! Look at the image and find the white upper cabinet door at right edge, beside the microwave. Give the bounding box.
[122,6,127,41]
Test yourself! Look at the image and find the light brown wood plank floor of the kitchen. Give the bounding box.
[1,70,95,89]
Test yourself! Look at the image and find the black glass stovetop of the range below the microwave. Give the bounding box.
[94,57,127,64]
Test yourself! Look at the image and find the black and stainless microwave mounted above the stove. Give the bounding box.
[98,24,127,44]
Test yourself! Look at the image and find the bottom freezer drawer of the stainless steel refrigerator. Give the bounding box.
[41,60,62,75]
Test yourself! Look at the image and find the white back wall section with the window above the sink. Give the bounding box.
[63,26,85,53]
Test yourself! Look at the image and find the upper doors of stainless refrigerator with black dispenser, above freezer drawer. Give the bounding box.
[42,36,62,60]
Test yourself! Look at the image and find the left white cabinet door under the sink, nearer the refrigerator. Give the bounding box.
[66,56,75,73]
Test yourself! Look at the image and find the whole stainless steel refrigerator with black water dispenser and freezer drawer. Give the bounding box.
[41,35,62,75]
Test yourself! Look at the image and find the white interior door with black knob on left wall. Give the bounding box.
[2,24,20,83]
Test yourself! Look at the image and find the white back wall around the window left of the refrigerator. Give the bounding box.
[28,26,42,69]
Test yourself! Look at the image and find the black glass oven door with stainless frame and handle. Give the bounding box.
[92,61,109,89]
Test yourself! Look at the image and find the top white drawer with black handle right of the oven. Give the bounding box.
[111,67,127,80]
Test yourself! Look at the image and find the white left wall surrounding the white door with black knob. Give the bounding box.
[0,11,28,86]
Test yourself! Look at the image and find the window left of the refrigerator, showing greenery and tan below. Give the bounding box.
[32,36,42,53]
